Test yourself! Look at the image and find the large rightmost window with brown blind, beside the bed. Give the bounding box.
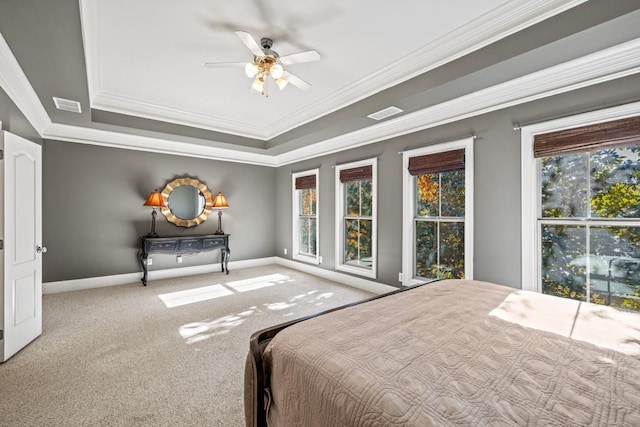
[523,112,640,310]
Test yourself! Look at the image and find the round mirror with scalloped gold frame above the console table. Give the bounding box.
[161,177,212,227]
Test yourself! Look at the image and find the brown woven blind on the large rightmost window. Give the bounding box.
[533,116,640,158]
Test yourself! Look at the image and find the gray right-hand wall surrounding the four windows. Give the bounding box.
[276,76,640,288]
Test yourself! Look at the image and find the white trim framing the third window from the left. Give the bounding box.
[402,137,474,286]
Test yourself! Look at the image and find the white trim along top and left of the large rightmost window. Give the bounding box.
[520,102,640,292]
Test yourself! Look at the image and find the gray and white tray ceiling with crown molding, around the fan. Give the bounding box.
[0,0,640,166]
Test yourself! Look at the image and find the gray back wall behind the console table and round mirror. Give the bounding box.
[42,140,275,282]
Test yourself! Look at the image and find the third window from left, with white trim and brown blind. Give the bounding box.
[402,138,473,285]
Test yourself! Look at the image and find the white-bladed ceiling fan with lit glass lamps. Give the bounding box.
[204,31,320,96]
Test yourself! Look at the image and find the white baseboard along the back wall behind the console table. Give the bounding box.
[42,257,277,294]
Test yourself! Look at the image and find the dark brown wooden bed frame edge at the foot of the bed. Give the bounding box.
[249,279,442,427]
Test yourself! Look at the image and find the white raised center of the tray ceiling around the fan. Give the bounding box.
[80,0,524,140]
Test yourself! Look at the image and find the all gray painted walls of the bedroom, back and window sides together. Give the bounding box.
[7,72,640,287]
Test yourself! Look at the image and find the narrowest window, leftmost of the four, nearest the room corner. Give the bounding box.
[292,169,320,264]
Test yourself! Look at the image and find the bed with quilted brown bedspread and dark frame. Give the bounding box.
[245,280,640,427]
